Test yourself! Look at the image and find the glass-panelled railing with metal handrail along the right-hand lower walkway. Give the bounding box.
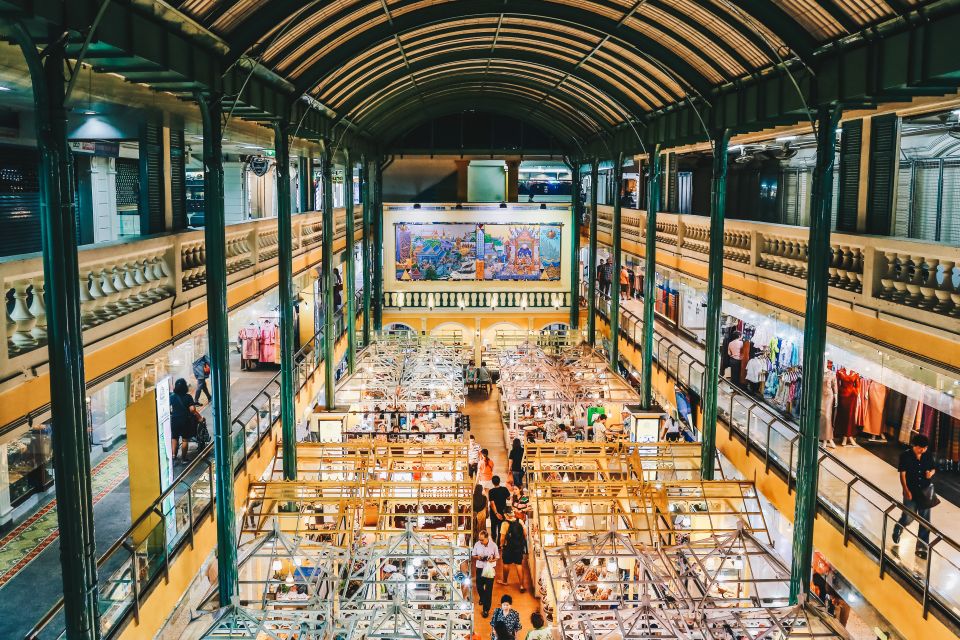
[596,295,960,624]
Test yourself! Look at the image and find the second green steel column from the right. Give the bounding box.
[700,130,730,480]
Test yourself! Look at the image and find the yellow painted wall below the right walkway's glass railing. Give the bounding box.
[597,316,953,640]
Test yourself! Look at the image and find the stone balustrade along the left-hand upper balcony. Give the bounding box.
[0,210,346,373]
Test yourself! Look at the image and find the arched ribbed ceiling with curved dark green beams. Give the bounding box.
[172,0,923,146]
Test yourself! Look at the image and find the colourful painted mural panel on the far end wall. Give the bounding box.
[394,222,561,282]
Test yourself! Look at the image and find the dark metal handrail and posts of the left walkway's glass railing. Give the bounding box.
[25,309,362,640]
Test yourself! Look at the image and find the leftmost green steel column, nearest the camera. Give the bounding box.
[21,33,100,640]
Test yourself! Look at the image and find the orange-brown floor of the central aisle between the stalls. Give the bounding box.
[466,387,540,638]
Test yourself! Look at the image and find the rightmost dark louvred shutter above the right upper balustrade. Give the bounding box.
[866,113,900,236]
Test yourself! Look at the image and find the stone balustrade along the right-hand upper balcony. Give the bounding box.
[598,205,960,334]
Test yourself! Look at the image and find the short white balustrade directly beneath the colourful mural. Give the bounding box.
[383,291,570,311]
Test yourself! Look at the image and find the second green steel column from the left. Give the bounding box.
[197,96,239,605]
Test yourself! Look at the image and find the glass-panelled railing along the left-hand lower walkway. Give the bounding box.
[25,307,361,640]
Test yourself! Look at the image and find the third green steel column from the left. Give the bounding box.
[273,120,297,480]
